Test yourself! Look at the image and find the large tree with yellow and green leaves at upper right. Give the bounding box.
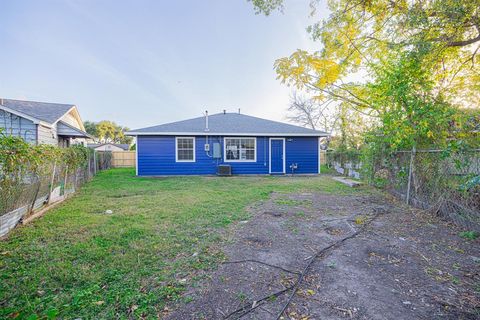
[253,0,480,148]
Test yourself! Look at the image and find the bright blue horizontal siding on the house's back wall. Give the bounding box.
[137,136,318,176]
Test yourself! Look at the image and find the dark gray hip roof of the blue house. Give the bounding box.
[127,113,329,137]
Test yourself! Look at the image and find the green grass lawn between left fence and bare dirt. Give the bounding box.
[0,169,364,319]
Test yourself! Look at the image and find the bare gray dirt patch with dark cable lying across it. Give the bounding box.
[165,193,480,320]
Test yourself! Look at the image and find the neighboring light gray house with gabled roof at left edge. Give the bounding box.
[0,98,90,147]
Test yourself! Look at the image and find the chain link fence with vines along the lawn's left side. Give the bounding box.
[0,151,112,237]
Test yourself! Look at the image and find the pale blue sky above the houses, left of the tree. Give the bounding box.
[0,0,327,128]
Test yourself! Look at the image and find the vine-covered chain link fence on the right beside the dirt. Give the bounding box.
[327,149,480,231]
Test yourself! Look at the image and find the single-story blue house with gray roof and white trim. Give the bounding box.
[127,112,328,176]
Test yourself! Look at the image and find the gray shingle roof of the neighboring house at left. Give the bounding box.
[0,99,73,124]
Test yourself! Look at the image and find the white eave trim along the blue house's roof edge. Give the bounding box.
[125,131,330,138]
